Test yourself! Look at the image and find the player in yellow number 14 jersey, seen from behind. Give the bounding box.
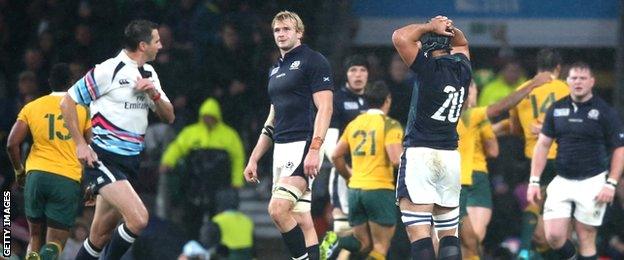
[509,49,570,259]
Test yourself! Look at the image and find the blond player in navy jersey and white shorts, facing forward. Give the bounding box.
[245,11,333,259]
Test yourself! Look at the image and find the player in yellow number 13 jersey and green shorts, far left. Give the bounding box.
[7,63,91,259]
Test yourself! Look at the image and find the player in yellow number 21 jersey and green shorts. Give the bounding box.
[321,82,403,259]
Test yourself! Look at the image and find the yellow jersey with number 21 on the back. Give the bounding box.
[340,109,403,190]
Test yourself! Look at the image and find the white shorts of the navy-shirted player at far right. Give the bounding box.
[544,172,607,226]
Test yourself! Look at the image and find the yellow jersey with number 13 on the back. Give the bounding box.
[17,92,91,181]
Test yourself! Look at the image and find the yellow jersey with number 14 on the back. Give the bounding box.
[510,80,570,159]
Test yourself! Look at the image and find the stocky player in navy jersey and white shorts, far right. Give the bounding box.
[527,62,624,259]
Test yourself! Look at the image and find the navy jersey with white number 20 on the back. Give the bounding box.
[403,51,472,150]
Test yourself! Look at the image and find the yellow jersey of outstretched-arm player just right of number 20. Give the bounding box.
[457,107,489,185]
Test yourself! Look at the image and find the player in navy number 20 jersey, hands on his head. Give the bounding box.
[392,16,472,259]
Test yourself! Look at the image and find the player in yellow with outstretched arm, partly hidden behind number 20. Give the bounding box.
[457,72,552,259]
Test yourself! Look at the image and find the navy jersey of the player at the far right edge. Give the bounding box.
[542,95,624,180]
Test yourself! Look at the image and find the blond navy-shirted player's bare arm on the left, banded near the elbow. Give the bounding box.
[244,105,275,183]
